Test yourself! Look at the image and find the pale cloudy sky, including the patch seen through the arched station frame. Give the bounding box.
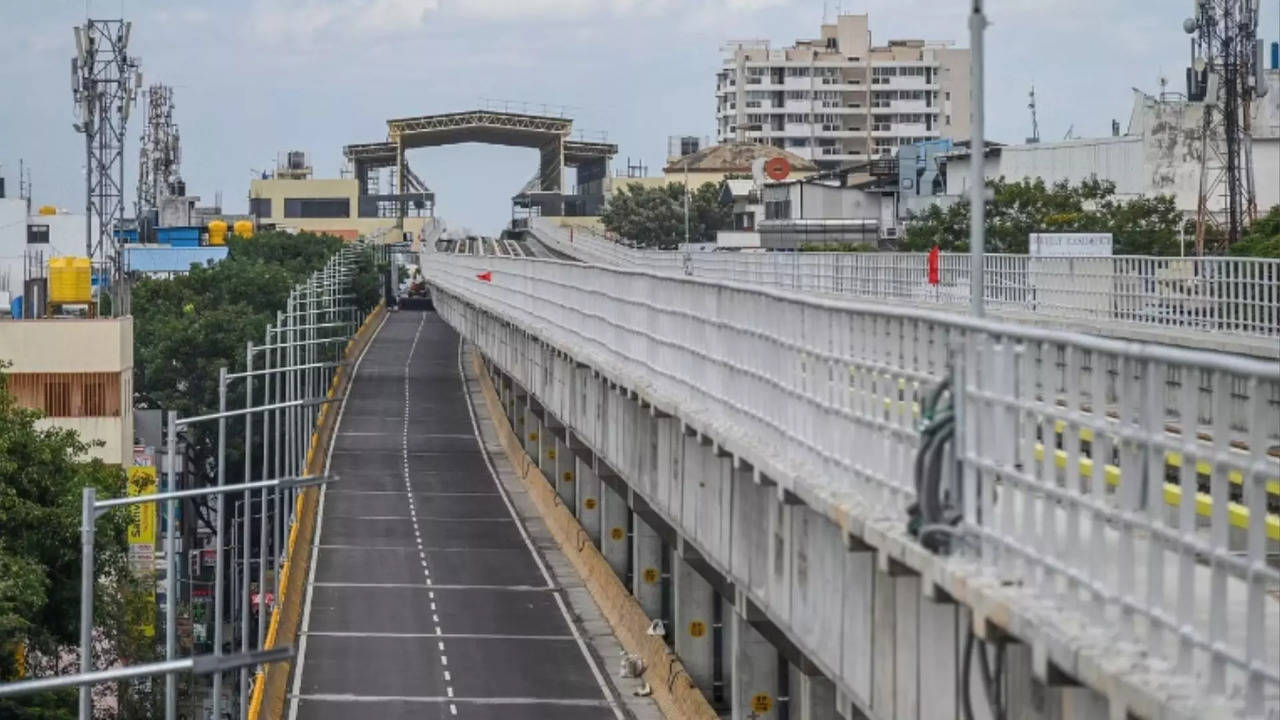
[0,0,1280,232]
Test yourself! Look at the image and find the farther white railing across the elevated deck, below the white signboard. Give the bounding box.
[532,218,1280,356]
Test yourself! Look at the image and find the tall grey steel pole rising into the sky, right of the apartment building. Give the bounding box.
[969,0,987,318]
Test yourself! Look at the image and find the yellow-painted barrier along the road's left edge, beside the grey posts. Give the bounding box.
[248,302,387,720]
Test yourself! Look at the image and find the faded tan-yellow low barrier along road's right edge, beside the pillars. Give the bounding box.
[471,348,717,720]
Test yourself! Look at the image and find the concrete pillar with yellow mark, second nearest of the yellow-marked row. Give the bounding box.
[671,548,717,698]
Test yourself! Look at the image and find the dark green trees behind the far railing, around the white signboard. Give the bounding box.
[904,178,1185,255]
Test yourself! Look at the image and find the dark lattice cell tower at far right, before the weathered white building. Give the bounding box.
[1183,0,1267,255]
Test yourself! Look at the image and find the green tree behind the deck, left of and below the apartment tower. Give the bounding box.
[600,182,732,250]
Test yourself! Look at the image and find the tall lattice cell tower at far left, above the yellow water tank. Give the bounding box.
[72,19,142,302]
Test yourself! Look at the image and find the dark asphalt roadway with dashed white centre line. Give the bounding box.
[289,311,622,720]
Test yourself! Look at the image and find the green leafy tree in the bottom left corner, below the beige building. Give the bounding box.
[0,368,141,720]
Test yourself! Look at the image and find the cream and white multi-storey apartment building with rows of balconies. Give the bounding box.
[716,15,969,167]
